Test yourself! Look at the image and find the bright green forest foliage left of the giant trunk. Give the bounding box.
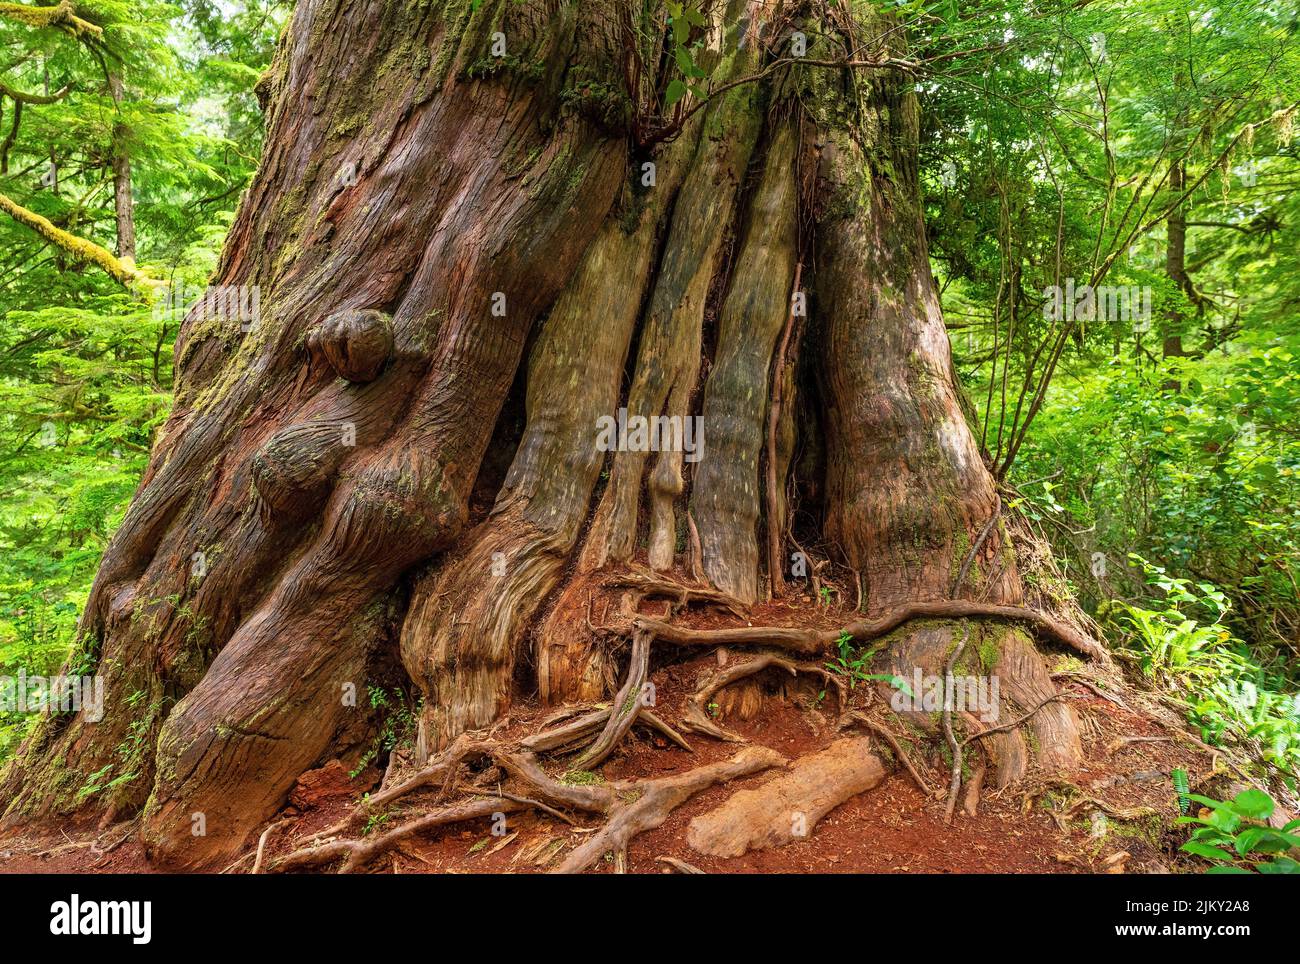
[0,0,286,763]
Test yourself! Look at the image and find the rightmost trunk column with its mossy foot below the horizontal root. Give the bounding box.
[810,9,1080,786]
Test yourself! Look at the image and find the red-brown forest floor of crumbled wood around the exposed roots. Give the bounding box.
[0,604,1222,873]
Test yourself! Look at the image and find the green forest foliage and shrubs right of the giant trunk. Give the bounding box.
[920,0,1300,789]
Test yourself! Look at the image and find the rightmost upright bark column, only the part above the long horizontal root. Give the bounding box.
[816,92,1019,613]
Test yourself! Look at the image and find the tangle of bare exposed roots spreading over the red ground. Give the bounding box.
[254,582,1091,873]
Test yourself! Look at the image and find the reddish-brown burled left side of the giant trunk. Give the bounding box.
[1,0,624,863]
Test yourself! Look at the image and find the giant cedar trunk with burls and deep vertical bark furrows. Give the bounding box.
[5,0,1097,867]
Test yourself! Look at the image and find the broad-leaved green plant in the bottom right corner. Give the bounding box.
[1175,790,1300,873]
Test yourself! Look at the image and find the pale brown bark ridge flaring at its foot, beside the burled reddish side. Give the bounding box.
[402,126,698,755]
